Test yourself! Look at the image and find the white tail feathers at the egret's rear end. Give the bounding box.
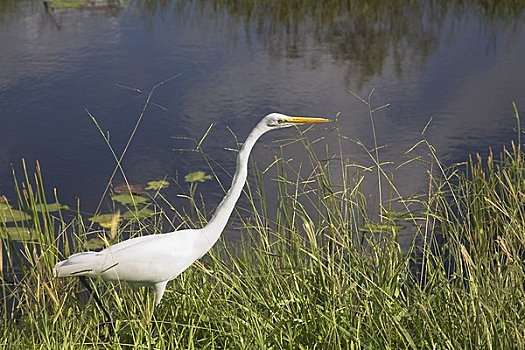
[53,252,106,277]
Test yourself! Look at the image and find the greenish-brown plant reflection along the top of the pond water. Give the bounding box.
[137,0,525,88]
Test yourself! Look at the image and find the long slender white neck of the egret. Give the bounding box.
[203,125,267,247]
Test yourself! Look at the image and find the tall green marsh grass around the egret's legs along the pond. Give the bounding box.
[0,101,525,349]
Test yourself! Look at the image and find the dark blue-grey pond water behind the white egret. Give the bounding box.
[0,0,525,235]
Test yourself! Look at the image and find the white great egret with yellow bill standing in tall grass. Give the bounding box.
[53,113,330,308]
